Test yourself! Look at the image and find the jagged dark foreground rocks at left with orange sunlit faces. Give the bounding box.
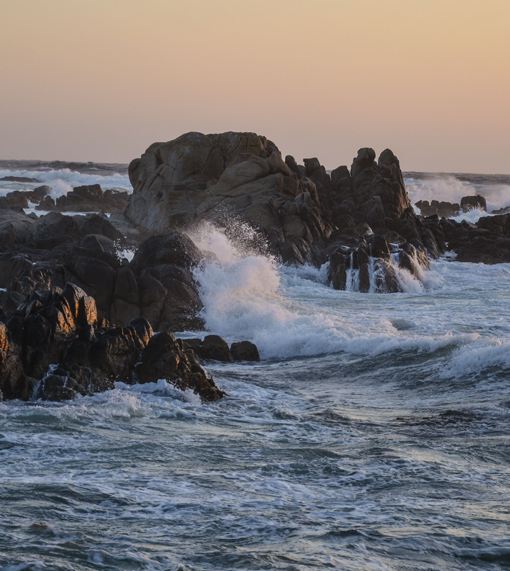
[0,283,224,401]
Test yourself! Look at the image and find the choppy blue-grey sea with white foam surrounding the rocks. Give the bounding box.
[0,163,510,571]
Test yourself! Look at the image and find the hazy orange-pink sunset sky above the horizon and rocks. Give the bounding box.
[0,0,510,174]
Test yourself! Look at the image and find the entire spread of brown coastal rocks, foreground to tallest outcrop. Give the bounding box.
[0,132,510,401]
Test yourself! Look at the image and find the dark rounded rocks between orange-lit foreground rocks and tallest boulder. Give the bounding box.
[0,231,204,331]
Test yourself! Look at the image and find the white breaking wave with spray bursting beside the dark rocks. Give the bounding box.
[186,224,476,359]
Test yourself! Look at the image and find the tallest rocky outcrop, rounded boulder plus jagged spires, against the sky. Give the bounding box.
[124,133,442,291]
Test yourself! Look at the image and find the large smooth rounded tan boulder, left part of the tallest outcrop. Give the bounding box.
[124,132,331,263]
